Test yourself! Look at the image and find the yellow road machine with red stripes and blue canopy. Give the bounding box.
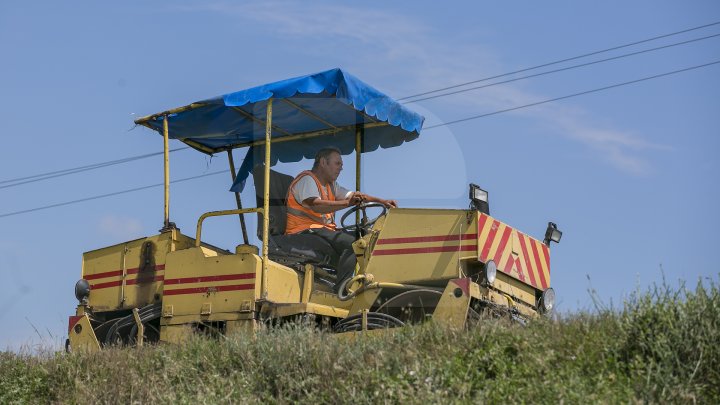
[67,69,561,350]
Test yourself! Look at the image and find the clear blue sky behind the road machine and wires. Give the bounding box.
[0,1,720,348]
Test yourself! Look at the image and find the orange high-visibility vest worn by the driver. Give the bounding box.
[285,170,335,234]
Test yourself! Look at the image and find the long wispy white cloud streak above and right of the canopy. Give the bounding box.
[177,1,669,175]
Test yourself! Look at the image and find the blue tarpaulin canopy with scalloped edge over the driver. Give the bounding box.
[135,69,425,191]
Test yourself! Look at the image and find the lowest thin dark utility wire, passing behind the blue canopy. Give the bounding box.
[0,60,720,218]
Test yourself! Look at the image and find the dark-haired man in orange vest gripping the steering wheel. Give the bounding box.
[285,147,397,285]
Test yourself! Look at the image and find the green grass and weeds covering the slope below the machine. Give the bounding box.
[0,281,720,404]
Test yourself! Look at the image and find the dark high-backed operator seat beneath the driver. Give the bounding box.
[252,164,336,268]
